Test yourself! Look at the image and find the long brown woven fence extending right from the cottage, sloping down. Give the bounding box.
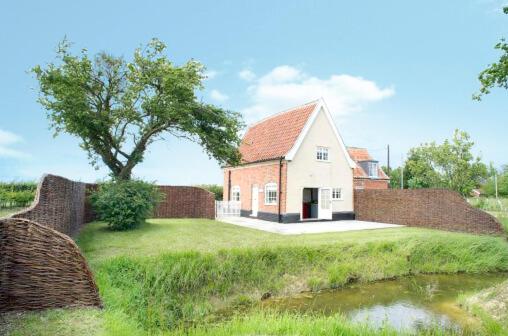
[354,189,503,234]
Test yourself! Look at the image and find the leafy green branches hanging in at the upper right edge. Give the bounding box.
[473,7,508,100]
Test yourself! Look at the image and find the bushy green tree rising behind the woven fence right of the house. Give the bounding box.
[405,130,487,196]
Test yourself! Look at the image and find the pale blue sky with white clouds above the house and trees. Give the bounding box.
[0,0,508,185]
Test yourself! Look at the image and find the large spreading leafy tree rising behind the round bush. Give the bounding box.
[32,39,243,180]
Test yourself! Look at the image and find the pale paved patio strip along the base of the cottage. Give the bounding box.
[217,217,404,235]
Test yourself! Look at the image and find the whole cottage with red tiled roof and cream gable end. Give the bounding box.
[224,99,356,223]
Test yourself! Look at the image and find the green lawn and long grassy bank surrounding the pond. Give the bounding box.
[4,220,508,335]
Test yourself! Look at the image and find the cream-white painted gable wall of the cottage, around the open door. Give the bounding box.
[286,109,353,217]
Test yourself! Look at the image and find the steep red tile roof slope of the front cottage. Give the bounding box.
[240,101,318,163]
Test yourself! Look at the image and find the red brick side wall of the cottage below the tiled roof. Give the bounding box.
[224,160,287,214]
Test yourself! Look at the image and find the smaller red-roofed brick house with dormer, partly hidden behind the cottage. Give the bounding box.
[347,147,390,189]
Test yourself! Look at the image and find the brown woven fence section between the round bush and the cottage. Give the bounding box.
[153,186,215,219]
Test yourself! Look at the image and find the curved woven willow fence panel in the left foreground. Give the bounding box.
[0,218,101,311]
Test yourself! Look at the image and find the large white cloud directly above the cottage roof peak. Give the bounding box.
[242,65,395,121]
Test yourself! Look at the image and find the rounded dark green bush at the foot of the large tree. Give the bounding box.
[90,180,163,230]
